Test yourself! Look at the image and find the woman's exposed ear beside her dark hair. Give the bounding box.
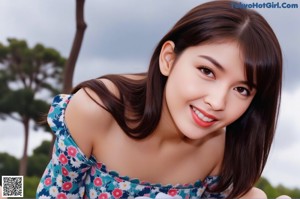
[159,41,175,76]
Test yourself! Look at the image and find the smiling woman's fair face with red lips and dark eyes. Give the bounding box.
[160,42,256,139]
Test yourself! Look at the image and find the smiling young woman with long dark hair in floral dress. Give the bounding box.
[37,1,282,198]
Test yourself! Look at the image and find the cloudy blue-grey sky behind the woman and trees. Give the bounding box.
[0,0,300,187]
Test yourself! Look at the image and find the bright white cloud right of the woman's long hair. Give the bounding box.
[263,87,300,187]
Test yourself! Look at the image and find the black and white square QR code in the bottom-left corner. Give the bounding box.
[2,176,23,197]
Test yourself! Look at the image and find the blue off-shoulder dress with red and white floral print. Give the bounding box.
[36,94,226,199]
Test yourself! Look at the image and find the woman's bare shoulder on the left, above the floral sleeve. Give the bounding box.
[65,80,118,157]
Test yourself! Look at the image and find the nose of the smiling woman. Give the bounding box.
[204,88,227,111]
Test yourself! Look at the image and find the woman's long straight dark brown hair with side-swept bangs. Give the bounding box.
[73,1,282,198]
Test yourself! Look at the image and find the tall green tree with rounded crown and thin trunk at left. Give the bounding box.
[0,39,65,176]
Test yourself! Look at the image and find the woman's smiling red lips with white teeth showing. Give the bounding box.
[191,106,217,127]
